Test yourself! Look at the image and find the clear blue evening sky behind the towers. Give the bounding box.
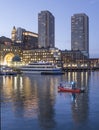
[0,0,99,58]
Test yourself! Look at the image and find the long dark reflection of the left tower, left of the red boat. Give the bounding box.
[31,76,57,130]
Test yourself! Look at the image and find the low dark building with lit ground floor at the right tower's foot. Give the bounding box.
[61,50,89,69]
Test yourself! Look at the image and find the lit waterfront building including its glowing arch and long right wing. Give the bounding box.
[0,40,61,66]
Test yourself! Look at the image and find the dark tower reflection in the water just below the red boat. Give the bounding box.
[71,93,89,123]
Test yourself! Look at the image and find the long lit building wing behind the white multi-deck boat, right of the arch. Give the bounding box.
[23,48,61,65]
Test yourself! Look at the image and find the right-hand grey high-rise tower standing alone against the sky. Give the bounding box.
[71,13,89,57]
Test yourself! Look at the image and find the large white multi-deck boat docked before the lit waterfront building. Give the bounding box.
[20,62,63,74]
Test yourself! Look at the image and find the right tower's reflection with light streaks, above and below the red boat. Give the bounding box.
[66,72,90,123]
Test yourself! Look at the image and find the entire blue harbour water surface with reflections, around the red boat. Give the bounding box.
[0,71,99,130]
